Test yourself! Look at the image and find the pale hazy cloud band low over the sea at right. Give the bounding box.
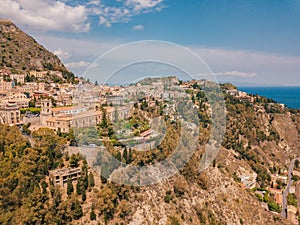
[196,46,300,85]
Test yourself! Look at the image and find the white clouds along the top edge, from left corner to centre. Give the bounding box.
[0,0,165,32]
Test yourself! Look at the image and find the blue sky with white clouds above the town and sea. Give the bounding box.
[0,0,300,86]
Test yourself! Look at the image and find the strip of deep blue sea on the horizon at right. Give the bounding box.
[238,86,300,109]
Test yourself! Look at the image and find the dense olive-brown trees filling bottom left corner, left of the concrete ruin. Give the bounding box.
[0,125,64,224]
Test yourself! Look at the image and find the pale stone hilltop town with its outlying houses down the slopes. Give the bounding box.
[0,65,300,224]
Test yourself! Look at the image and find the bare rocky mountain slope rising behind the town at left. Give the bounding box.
[0,19,67,72]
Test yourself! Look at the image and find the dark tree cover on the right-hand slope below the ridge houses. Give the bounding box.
[223,91,282,187]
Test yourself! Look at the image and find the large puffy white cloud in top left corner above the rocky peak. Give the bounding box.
[0,0,90,32]
